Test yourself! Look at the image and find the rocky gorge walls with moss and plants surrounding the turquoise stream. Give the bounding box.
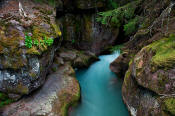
[0,0,175,116]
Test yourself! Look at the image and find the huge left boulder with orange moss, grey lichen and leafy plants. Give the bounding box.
[0,0,60,99]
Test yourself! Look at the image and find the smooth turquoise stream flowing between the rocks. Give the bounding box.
[70,52,129,116]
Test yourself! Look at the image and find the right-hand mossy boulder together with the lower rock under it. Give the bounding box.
[122,35,175,116]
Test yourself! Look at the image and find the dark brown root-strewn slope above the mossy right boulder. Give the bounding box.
[112,0,174,78]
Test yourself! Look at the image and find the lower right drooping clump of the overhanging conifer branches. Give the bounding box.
[124,17,138,35]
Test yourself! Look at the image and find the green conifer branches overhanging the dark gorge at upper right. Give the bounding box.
[96,0,141,35]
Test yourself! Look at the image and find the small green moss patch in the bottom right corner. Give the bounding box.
[164,98,175,116]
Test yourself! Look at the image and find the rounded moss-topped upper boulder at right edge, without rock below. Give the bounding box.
[133,36,175,95]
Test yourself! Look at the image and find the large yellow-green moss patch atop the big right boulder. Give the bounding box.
[148,35,175,70]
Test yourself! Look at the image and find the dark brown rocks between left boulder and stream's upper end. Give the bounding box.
[50,48,99,73]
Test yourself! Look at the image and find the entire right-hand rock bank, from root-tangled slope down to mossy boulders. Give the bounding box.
[111,0,175,116]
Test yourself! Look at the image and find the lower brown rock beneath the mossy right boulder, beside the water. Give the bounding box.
[122,69,163,116]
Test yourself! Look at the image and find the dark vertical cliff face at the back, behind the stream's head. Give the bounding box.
[63,14,119,55]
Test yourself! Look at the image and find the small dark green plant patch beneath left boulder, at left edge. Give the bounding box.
[0,92,14,107]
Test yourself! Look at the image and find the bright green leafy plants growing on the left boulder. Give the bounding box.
[25,34,54,48]
